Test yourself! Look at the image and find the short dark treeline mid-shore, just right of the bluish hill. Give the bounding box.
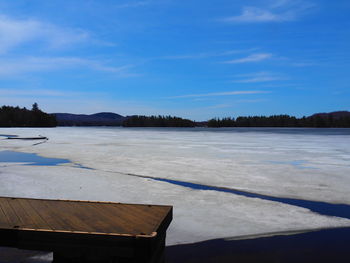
[122,115,196,127]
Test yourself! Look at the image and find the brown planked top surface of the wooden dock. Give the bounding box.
[0,197,172,236]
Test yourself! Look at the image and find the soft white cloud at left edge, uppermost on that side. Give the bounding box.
[0,15,89,54]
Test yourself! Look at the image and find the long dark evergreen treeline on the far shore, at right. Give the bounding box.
[207,113,350,128]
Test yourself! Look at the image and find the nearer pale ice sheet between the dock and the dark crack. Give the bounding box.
[0,166,350,244]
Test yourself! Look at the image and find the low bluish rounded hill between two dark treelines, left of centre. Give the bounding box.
[53,112,125,126]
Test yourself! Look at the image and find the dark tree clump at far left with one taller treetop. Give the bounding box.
[0,103,57,127]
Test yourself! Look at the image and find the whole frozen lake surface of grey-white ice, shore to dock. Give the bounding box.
[0,127,350,248]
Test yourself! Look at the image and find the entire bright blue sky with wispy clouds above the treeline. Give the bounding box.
[0,0,350,120]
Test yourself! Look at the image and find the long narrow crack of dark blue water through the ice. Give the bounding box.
[133,176,350,219]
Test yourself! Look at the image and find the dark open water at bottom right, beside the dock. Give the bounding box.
[166,226,350,263]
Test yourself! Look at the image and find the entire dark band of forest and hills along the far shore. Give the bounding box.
[0,103,350,128]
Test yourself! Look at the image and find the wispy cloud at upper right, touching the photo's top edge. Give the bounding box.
[222,0,315,23]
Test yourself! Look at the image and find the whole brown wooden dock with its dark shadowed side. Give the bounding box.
[0,197,172,263]
